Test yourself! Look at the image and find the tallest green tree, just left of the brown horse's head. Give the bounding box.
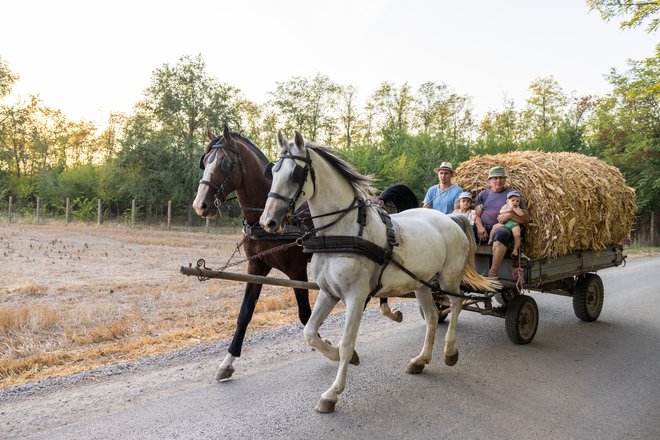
[122,55,244,220]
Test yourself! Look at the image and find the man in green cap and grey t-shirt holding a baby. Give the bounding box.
[475,166,529,277]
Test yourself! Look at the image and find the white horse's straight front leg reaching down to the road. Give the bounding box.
[312,298,364,413]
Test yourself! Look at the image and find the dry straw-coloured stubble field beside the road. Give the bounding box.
[0,223,377,388]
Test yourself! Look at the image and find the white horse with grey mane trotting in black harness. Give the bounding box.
[260,132,498,413]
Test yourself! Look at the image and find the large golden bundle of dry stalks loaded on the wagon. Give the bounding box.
[454,151,635,258]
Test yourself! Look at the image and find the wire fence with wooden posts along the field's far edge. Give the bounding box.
[0,196,241,232]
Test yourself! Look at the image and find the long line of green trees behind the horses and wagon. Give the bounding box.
[0,45,660,227]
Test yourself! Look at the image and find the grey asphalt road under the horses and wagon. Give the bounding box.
[0,257,660,440]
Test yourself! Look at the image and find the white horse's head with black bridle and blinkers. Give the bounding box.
[259,130,315,232]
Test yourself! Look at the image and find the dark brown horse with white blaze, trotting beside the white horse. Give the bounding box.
[193,126,419,381]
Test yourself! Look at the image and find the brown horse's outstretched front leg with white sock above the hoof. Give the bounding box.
[215,260,270,382]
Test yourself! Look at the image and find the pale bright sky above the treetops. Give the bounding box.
[0,0,660,125]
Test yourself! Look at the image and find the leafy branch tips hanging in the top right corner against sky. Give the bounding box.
[587,0,660,33]
